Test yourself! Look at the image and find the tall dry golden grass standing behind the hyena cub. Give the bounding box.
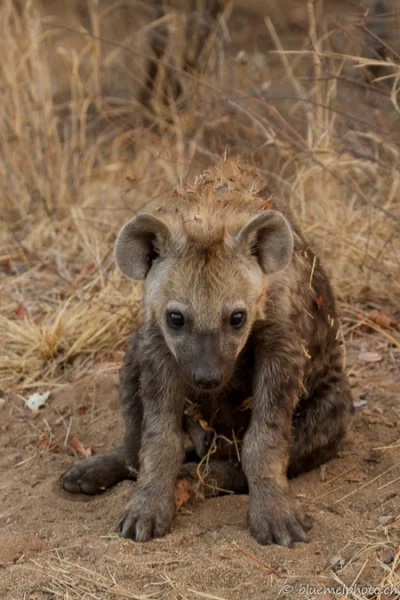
[0,0,400,390]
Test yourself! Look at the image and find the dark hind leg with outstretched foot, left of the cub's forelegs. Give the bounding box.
[61,332,142,494]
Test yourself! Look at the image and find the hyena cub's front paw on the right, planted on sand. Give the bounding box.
[249,489,310,548]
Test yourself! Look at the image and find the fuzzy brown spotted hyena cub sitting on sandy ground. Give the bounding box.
[62,161,352,546]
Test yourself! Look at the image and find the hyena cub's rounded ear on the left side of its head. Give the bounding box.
[115,214,171,279]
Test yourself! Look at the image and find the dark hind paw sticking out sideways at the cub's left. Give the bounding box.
[61,450,132,494]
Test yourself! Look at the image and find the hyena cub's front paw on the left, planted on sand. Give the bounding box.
[118,491,175,542]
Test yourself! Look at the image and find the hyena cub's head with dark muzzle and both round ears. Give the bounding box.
[115,210,293,391]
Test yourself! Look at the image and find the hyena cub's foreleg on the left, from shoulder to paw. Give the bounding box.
[120,324,185,542]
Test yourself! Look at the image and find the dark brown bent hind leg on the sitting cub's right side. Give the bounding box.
[288,370,354,477]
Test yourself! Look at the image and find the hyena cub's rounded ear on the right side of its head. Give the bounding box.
[236,210,293,274]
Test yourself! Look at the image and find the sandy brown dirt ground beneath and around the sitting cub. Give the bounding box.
[0,336,400,600]
